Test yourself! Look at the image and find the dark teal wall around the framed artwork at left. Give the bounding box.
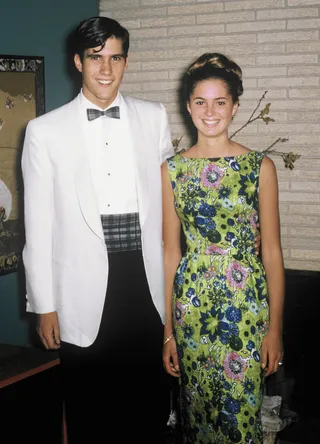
[0,0,99,345]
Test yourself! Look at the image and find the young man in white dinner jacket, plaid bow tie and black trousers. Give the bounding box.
[22,17,173,444]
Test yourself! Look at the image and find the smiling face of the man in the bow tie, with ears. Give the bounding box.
[74,38,128,109]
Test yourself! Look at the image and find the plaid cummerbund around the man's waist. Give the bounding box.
[101,213,142,253]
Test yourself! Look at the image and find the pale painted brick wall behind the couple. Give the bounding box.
[100,0,320,270]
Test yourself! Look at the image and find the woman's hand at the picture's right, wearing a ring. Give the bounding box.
[261,331,283,376]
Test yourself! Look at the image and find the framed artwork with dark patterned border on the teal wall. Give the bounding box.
[0,55,45,275]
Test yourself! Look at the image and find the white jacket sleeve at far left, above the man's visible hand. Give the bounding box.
[21,119,55,313]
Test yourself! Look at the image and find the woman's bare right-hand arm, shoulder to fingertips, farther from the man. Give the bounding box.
[259,157,285,376]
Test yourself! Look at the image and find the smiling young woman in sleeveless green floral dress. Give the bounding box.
[162,53,284,444]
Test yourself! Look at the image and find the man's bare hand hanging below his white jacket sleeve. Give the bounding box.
[37,311,60,350]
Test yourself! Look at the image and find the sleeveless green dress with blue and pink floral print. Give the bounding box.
[167,151,269,444]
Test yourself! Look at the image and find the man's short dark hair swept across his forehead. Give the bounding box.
[72,17,129,60]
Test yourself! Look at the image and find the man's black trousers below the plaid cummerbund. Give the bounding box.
[61,251,171,444]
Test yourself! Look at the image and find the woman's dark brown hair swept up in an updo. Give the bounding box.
[185,52,243,103]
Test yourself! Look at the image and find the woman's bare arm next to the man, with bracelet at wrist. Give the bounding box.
[161,162,182,376]
